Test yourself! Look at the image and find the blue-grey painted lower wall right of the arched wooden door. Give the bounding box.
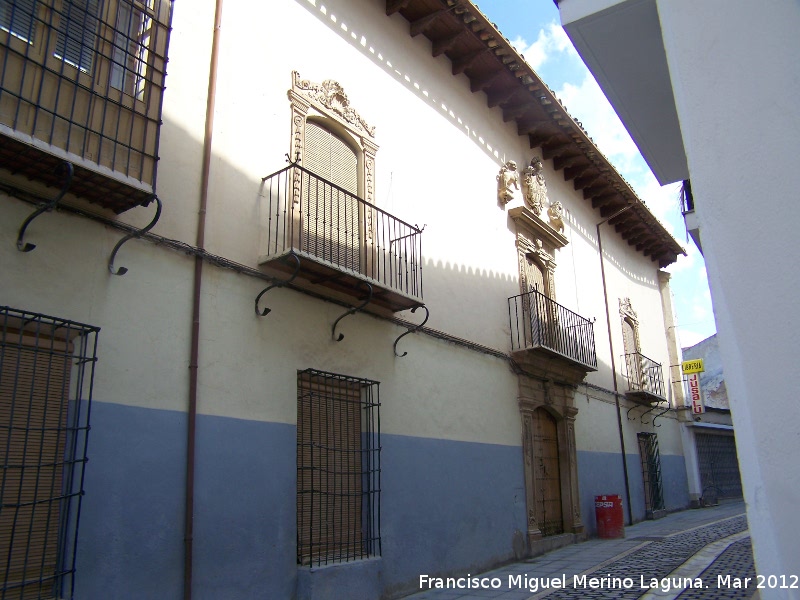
[578,451,689,536]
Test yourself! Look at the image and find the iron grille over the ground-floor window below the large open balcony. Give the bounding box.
[297,369,381,565]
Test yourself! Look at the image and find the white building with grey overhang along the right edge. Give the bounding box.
[558,0,800,598]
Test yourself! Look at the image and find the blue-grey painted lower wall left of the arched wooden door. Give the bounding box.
[76,402,525,600]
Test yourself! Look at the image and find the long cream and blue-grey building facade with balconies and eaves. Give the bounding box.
[0,0,689,599]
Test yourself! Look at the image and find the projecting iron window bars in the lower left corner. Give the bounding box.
[0,307,99,600]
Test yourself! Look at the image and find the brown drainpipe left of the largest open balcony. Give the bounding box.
[183,0,222,600]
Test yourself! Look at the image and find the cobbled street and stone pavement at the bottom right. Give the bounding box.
[407,502,758,600]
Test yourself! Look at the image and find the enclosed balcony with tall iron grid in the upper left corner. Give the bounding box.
[0,0,172,214]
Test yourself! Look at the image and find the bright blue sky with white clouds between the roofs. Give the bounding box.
[478,0,716,348]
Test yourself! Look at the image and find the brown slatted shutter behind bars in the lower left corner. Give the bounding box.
[0,336,72,599]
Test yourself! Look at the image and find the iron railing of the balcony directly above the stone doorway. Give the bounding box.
[508,290,597,371]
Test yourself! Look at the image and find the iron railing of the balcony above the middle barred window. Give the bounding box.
[263,163,422,298]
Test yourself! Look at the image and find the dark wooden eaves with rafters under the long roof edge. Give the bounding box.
[386,0,686,268]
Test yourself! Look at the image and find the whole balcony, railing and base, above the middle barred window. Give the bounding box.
[259,163,423,312]
